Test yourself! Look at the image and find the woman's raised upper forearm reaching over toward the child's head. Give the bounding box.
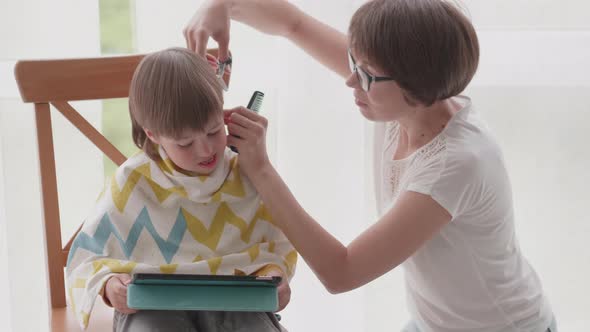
[226,0,350,77]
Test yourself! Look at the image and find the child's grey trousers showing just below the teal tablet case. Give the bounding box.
[113,310,286,332]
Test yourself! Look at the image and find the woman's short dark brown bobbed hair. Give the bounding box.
[349,0,479,106]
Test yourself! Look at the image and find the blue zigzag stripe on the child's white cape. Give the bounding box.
[68,207,186,264]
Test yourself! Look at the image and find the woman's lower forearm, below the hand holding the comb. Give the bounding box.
[251,164,351,293]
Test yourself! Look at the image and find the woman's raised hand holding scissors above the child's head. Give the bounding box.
[182,0,230,60]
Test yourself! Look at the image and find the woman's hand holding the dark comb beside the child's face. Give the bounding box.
[224,107,270,181]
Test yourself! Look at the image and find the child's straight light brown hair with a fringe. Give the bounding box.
[129,48,223,160]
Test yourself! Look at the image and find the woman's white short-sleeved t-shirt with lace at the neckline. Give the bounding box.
[375,97,553,332]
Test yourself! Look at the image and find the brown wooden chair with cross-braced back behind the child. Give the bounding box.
[14,49,230,332]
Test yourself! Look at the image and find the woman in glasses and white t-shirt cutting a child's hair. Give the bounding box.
[184,0,556,332]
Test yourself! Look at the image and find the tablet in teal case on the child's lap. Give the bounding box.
[127,274,280,312]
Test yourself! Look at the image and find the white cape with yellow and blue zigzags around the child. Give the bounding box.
[66,148,297,328]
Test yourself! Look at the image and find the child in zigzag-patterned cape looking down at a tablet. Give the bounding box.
[66,48,297,331]
